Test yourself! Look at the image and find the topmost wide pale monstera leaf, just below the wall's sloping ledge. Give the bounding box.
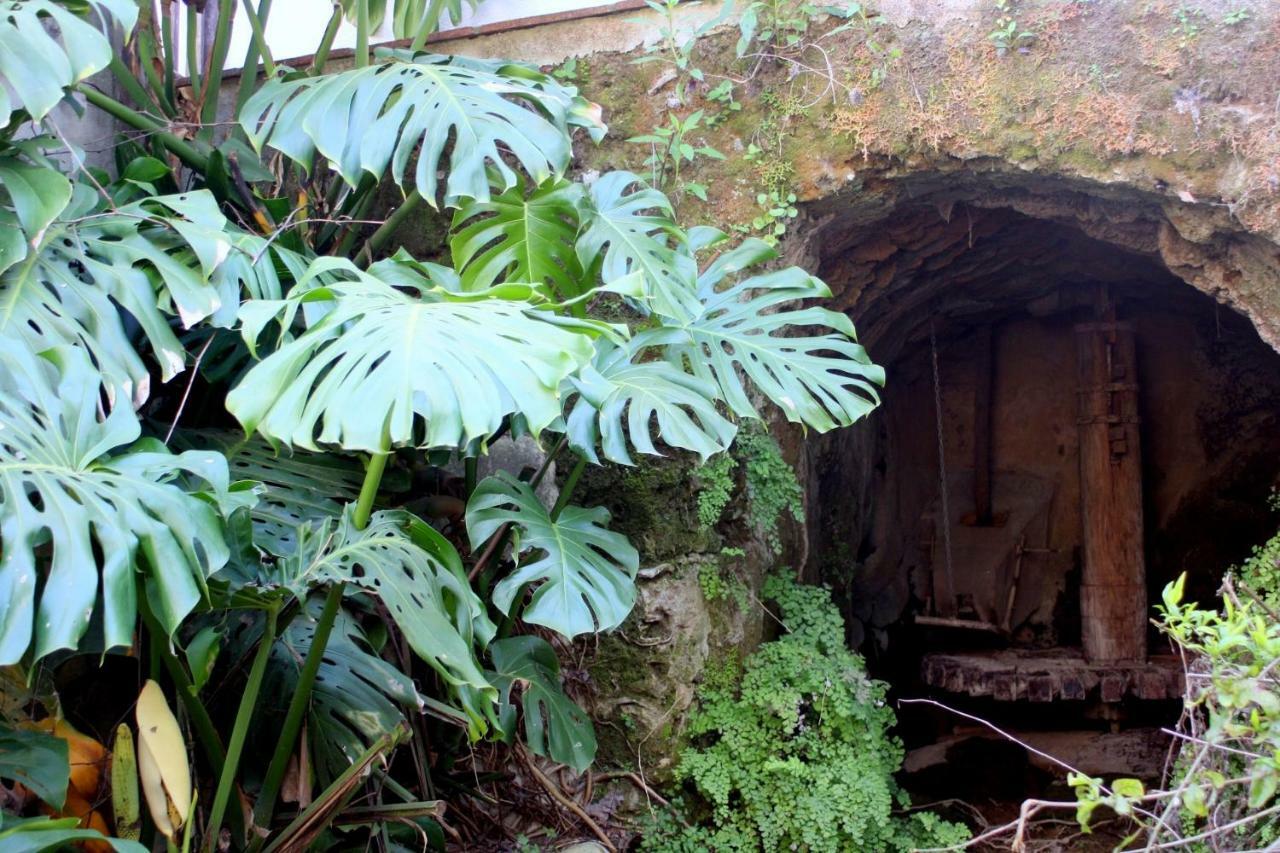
[241,50,603,206]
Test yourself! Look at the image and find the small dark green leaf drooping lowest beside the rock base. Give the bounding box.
[490,637,595,772]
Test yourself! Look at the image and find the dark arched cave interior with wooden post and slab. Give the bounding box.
[806,172,1280,794]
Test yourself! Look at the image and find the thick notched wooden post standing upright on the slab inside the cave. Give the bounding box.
[1075,320,1147,662]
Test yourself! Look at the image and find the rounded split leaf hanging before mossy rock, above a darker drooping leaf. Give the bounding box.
[467,473,640,639]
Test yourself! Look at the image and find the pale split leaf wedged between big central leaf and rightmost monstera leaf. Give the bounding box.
[568,341,737,465]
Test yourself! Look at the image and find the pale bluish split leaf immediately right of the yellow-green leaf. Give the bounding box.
[576,172,701,320]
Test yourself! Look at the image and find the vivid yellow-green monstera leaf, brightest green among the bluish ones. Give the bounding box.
[449,181,586,300]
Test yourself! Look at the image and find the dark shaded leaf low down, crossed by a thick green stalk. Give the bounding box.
[262,597,424,781]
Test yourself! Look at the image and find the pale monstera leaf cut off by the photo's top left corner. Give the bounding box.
[0,0,138,131]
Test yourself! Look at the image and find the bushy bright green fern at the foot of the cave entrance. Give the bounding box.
[641,578,968,853]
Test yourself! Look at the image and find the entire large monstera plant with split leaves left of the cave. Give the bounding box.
[0,0,882,849]
